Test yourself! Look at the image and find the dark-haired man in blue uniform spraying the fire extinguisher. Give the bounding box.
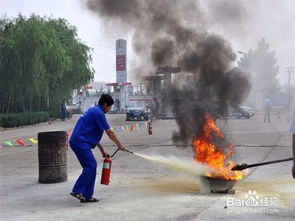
[70,94,126,203]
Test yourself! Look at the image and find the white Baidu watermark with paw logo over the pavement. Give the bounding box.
[226,190,279,214]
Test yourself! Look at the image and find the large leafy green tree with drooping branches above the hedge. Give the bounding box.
[0,15,94,116]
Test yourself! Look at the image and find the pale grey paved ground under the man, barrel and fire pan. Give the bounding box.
[0,114,295,221]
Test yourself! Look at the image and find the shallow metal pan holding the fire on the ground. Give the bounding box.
[203,176,237,193]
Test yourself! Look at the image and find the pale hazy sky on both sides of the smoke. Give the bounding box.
[0,0,295,84]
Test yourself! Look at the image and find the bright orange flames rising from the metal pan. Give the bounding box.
[193,114,244,180]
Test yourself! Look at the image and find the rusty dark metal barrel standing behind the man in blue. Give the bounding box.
[38,131,68,183]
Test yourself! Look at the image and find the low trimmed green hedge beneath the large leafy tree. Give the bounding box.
[0,111,49,128]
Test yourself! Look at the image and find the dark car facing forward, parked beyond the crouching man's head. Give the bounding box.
[126,102,150,121]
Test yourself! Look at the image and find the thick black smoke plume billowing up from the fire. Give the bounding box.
[87,0,250,143]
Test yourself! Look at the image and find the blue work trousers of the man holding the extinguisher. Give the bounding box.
[71,145,97,199]
